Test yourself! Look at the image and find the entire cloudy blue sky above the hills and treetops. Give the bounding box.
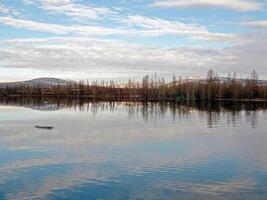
[0,0,267,82]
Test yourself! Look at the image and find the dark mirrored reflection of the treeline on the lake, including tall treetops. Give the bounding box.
[0,98,267,128]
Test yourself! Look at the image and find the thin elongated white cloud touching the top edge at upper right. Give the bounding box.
[152,0,264,12]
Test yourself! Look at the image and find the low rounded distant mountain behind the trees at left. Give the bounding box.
[0,77,75,87]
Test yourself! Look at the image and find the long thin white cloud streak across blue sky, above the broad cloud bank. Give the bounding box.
[0,16,237,41]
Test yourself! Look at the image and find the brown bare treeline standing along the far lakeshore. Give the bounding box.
[0,70,267,101]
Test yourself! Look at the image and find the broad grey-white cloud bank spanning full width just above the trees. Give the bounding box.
[0,35,267,80]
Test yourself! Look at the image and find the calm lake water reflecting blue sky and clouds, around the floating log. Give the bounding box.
[0,100,267,200]
